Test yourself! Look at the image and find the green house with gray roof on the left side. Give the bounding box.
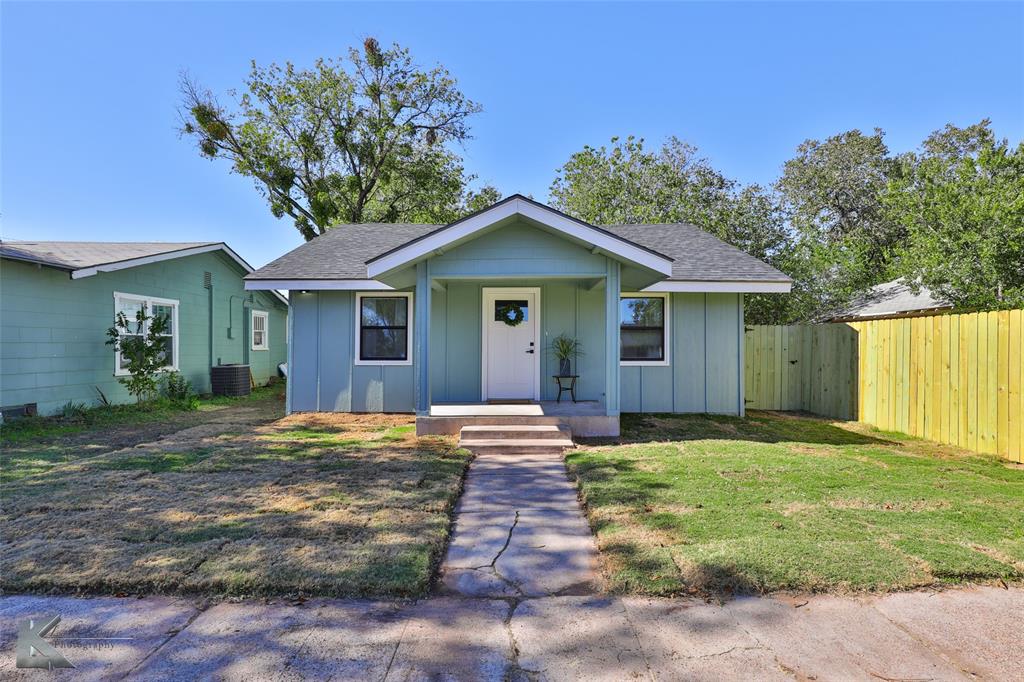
[0,241,288,415]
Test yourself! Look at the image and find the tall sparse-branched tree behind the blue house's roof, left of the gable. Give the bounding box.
[180,38,480,240]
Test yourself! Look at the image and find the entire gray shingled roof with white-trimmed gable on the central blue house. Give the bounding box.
[246,195,793,292]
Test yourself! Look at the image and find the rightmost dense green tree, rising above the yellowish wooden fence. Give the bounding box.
[884,120,1024,308]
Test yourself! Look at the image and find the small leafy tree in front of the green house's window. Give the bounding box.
[106,304,171,402]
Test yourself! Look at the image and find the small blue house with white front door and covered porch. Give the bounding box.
[246,195,791,435]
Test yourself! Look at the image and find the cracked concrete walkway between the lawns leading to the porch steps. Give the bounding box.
[441,454,599,597]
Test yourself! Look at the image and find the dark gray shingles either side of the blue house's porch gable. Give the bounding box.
[246,222,790,282]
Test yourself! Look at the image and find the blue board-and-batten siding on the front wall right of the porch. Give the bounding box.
[621,293,743,415]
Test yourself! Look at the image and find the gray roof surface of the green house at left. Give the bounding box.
[0,241,219,270]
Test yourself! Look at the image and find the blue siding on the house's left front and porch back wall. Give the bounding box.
[291,281,604,412]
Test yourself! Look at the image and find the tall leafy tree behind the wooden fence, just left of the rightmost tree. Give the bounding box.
[775,129,903,319]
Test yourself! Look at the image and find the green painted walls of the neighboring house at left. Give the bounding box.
[0,252,287,415]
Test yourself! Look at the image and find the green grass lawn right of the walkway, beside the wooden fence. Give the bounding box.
[567,413,1024,595]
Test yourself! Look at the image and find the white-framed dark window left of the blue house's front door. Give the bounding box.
[355,291,413,365]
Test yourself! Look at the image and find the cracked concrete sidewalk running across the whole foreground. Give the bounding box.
[0,587,1024,682]
